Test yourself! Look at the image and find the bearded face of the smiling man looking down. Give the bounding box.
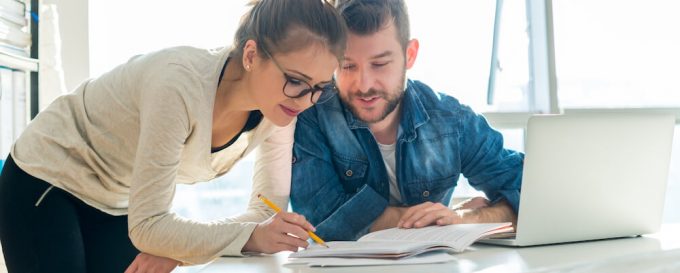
[337,23,406,124]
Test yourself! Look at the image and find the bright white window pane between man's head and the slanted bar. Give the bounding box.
[407,0,494,109]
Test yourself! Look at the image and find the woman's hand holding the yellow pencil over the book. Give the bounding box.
[243,212,316,254]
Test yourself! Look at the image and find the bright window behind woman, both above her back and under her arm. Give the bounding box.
[89,0,254,220]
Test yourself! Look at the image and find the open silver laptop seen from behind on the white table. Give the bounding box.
[480,113,675,246]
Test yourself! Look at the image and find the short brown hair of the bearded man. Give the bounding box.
[335,0,411,51]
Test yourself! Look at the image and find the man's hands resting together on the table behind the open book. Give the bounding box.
[397,197,517,228]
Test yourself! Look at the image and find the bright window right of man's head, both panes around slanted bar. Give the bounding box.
[406,0,529,111]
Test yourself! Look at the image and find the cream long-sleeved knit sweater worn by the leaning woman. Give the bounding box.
[11,47,295,264]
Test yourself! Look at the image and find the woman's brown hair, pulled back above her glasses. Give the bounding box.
[230,0,347,60]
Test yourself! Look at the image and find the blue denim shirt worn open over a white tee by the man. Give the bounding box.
[290,80,524,240]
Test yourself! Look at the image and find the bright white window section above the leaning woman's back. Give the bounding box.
[89,0,248,77]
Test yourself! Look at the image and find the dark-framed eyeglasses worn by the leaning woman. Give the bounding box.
[262,49,337,104]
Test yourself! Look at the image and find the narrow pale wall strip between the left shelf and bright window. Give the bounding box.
[41,0,90,92]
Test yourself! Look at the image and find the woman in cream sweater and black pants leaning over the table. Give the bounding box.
[0,0,345,272]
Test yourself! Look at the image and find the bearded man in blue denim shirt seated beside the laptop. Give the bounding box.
[291,0,524,240]
